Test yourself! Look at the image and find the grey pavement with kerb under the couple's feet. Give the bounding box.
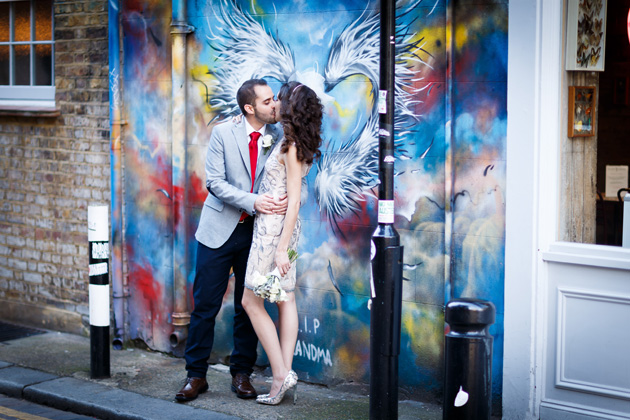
[0,332,442,420]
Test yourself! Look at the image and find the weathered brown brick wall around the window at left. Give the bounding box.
[0,0,110,333]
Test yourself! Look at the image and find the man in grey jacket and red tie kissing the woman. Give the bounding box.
[175,79,287,402]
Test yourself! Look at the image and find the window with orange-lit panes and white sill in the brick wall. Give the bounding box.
[0,0,55,108]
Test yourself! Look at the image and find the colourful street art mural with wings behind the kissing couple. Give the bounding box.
[121,0,507,402]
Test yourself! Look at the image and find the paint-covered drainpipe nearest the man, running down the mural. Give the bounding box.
[169,0,193,349]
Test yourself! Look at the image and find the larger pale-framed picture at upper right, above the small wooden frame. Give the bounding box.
[565,0,606,71]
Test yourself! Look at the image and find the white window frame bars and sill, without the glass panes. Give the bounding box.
[0,0,56,109]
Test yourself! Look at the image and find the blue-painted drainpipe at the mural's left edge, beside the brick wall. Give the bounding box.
[108,0,127,350]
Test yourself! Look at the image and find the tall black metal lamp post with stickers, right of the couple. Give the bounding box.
[370,0,403,420]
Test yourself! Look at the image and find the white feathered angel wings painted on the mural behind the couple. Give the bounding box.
[200,0,435,228]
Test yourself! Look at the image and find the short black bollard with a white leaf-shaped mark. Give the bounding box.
[442,298,496,420]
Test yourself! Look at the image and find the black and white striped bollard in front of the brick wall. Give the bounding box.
[88,206,110,379]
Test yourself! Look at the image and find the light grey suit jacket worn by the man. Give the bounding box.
[195,120,282,248]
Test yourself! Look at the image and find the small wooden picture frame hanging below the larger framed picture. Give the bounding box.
[568,86,597,137]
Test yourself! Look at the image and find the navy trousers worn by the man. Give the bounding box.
[184,218,258,378]
